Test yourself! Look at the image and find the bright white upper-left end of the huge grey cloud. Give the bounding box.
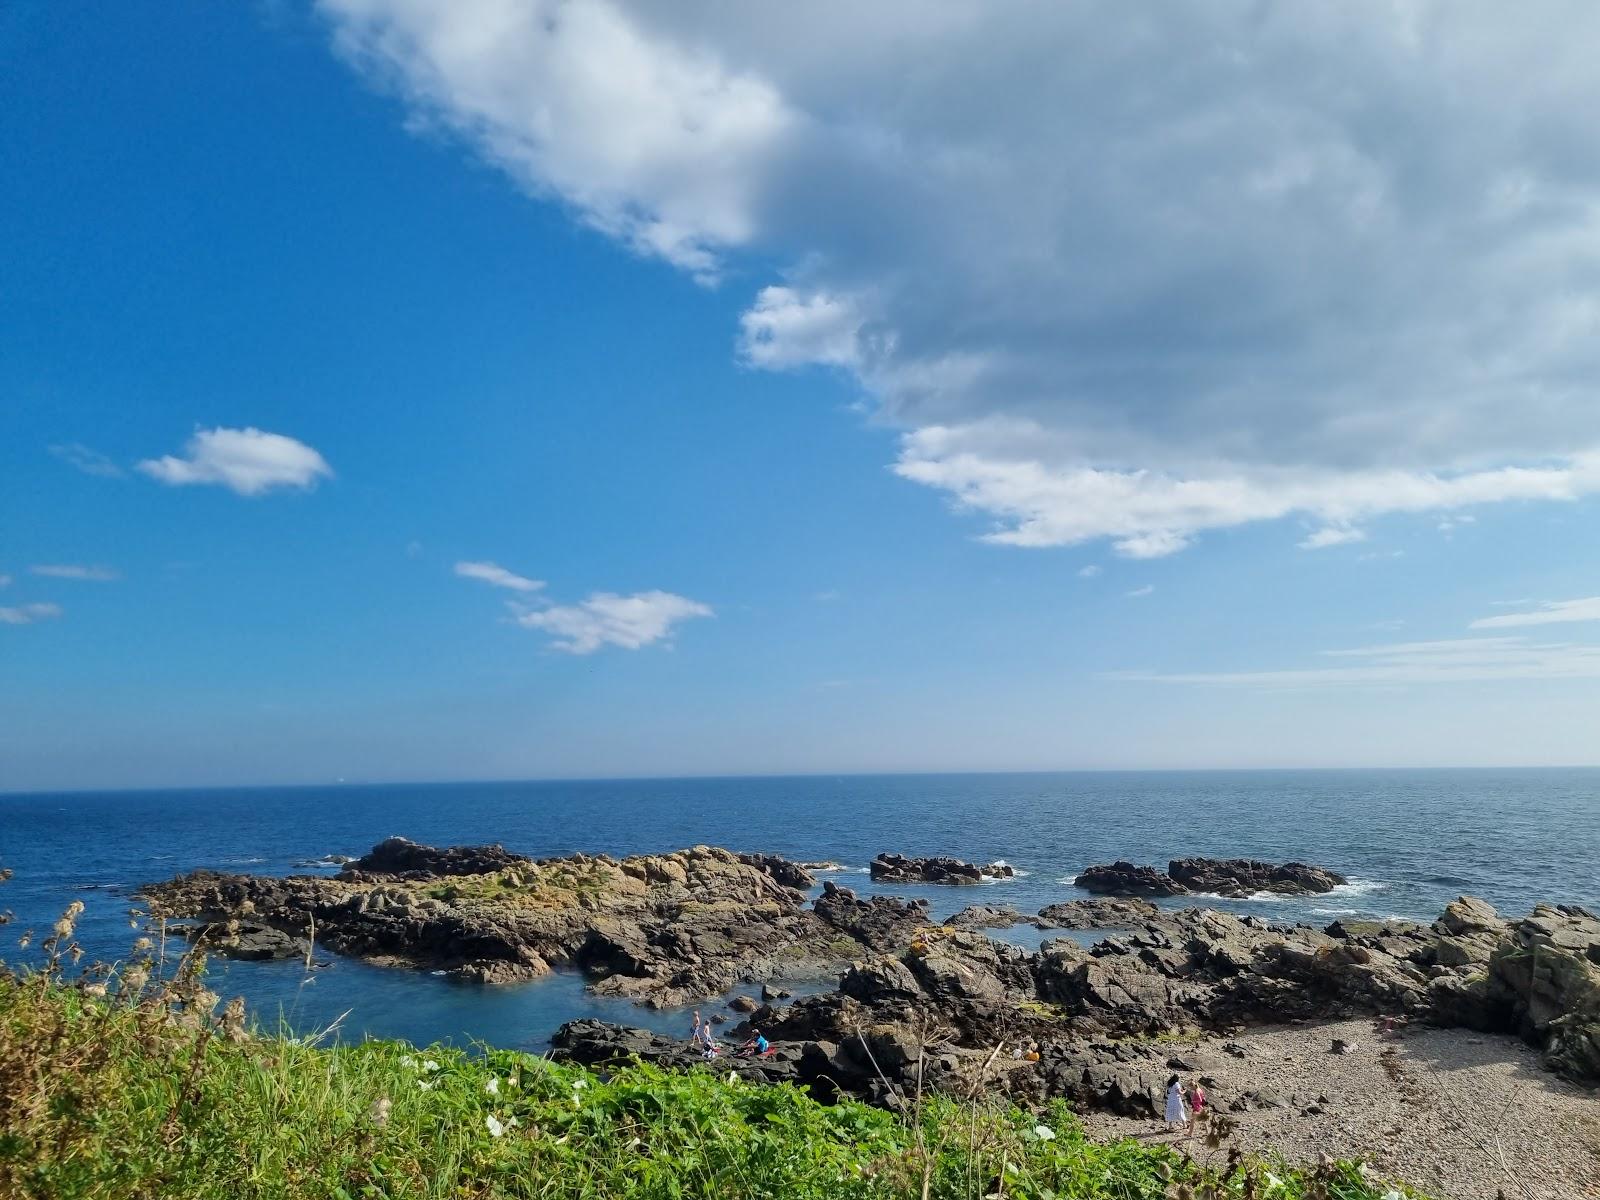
[320,0,797,280]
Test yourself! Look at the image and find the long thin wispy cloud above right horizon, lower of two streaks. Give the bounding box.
[1109,637,1600,688]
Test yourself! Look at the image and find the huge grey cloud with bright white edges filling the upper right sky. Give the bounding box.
[320,0,1600,557]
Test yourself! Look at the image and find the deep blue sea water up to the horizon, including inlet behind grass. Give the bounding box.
[0,768,1600,1050]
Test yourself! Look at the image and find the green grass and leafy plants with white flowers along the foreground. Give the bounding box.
[0,910,1427,1200]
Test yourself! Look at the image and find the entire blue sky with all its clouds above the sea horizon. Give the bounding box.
[0,0,1600,790]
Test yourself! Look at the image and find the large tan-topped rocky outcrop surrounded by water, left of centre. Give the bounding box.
[144,838,883,1005]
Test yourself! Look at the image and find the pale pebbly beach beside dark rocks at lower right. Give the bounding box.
[1085,1021,1600,1200]
